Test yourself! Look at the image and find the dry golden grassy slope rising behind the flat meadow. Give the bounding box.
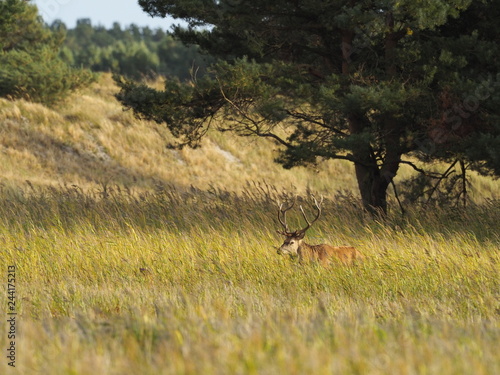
[0,75,500,203]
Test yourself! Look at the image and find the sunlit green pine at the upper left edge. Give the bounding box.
[0,0,95,105]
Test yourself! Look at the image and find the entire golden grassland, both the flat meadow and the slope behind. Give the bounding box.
[0,76,500,375]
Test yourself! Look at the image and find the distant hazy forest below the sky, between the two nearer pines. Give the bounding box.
[54,19,209,81]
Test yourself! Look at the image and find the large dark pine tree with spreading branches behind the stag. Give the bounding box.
[117,0,500,212]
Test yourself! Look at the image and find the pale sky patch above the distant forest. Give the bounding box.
[31,0,175,30]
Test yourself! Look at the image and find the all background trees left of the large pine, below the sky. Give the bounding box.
[0,0,210,105]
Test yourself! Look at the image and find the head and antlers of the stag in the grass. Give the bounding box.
[277,197,323,256]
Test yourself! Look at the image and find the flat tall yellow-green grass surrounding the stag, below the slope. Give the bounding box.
[0,186,500,375]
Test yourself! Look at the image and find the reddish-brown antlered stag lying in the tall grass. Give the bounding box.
[277,197,363,266]
